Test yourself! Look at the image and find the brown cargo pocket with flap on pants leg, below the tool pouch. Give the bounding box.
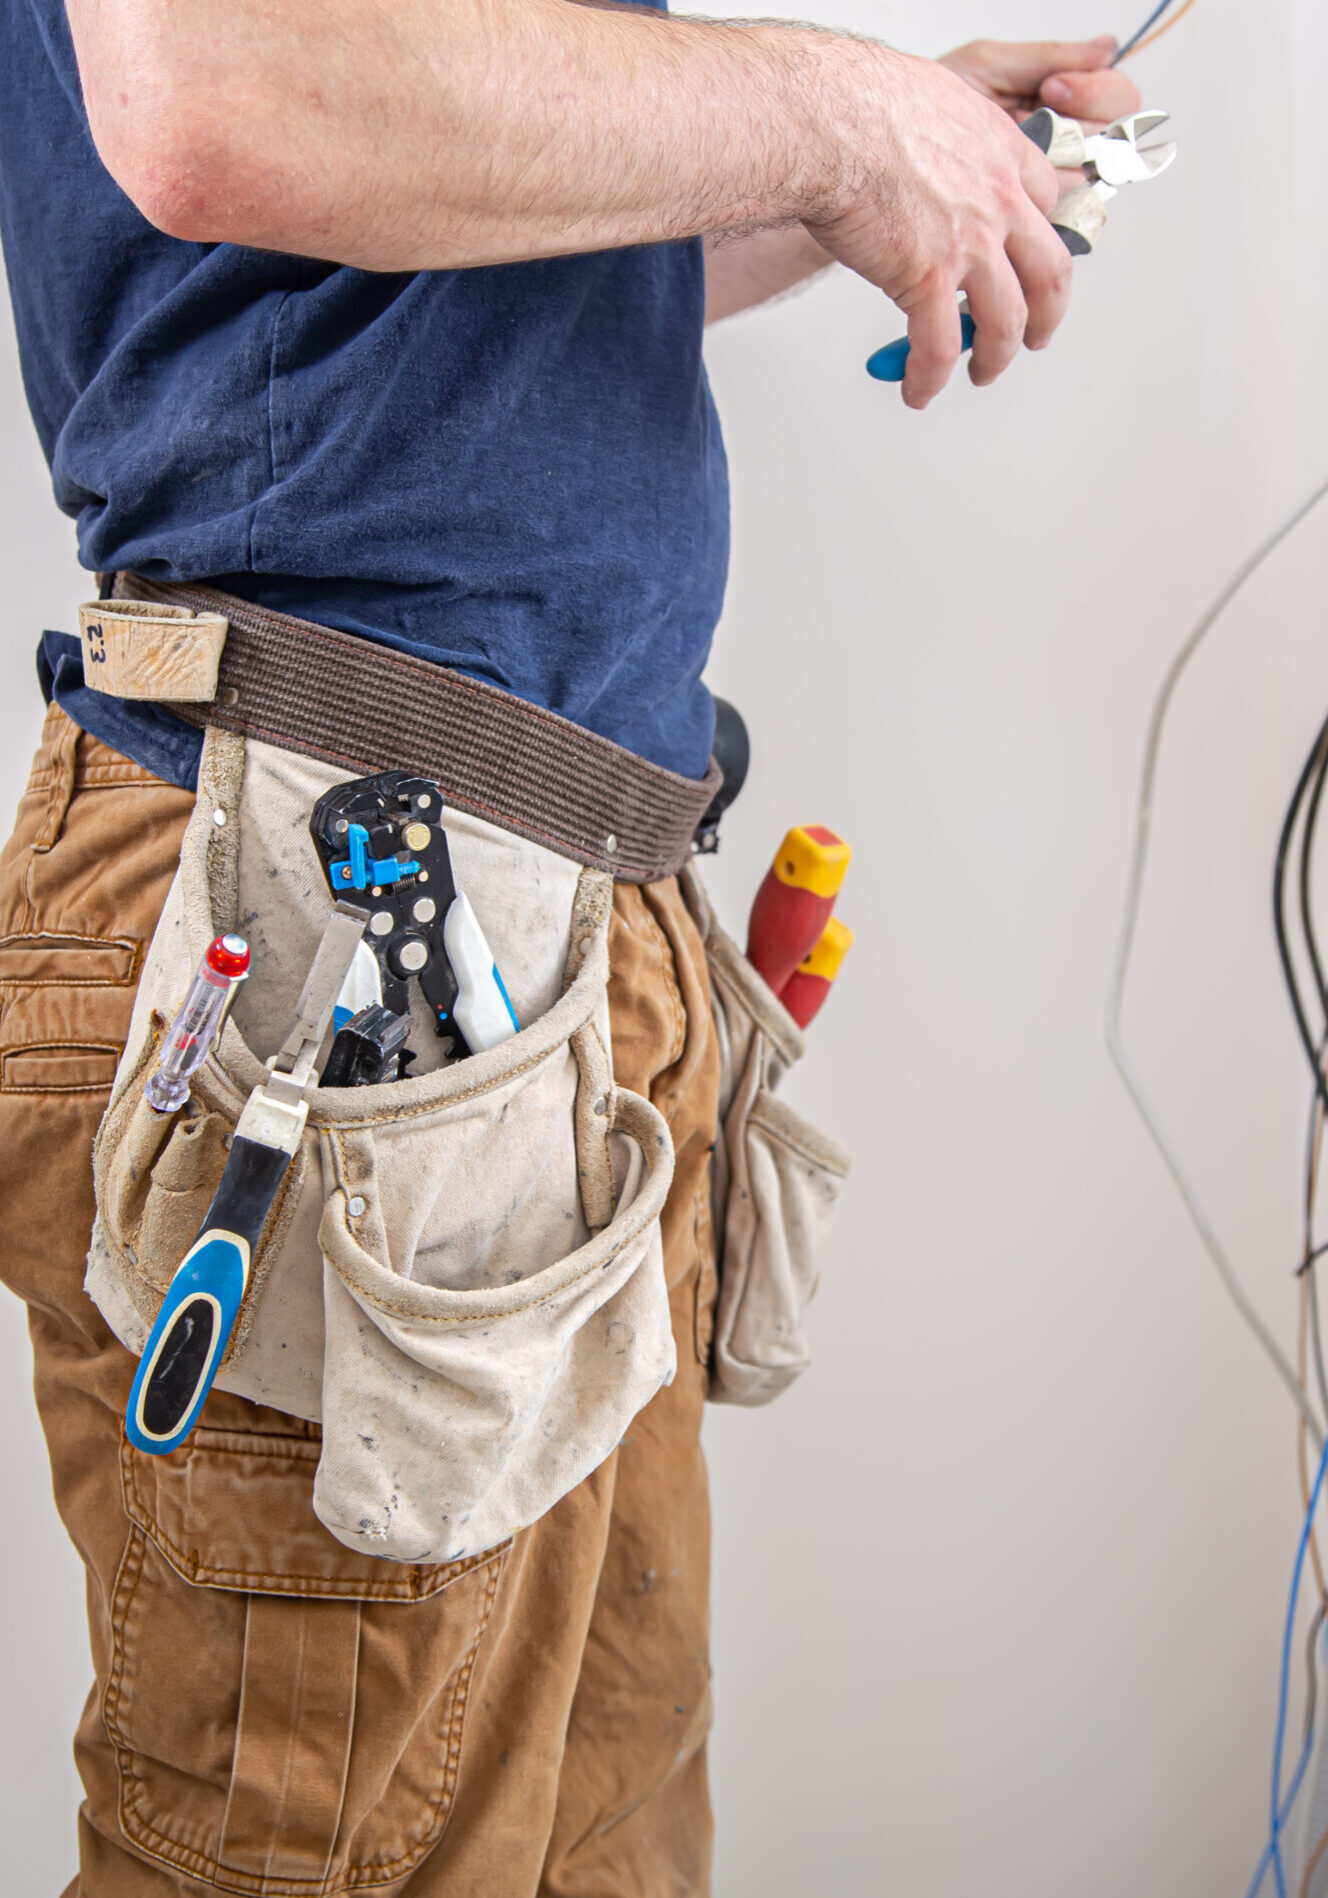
[102,1427,507,1898]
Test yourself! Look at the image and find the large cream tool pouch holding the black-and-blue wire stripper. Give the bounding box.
[87,729,673,1564]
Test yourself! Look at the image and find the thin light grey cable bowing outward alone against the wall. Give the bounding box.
[1106,480,1328,1448]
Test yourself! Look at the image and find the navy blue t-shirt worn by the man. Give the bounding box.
[0,0,729,784]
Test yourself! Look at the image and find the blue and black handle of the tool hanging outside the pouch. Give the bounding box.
[125,1133,290,1456]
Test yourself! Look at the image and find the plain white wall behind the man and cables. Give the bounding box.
[0,0,1328,1898]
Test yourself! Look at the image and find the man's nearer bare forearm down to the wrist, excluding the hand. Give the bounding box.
[68,0,857,270]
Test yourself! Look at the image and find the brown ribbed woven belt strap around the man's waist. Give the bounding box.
[112,573,719,883]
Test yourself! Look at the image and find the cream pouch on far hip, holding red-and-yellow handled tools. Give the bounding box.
[683,869,850,1405]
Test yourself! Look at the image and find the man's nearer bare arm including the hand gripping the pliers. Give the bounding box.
[66,0,1070,408]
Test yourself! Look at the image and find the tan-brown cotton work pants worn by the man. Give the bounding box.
[0,710,717,1898]
